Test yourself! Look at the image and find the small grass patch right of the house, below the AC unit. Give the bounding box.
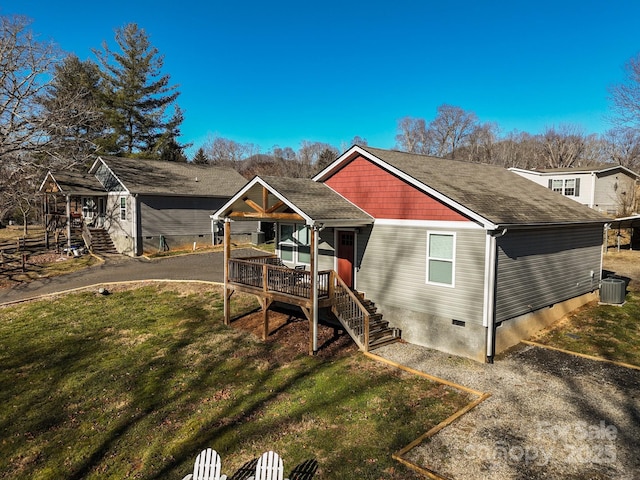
[536,292,640,366]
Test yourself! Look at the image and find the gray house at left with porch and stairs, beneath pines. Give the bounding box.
[40,156,257,255]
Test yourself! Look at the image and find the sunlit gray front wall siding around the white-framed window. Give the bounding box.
[356,225,486,324]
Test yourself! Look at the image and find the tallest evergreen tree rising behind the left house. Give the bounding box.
[94,23,183,158]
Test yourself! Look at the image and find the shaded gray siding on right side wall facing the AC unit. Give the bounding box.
[496,226,602,322]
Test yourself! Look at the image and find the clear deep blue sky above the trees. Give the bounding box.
[5,0,640,157]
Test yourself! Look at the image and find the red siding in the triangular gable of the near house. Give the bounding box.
[324,156,469,222]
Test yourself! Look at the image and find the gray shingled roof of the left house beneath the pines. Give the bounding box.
[99,156,247,197]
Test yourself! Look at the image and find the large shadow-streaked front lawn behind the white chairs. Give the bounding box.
[0,286,468,480]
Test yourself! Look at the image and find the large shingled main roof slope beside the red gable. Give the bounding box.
[362,147,608,225]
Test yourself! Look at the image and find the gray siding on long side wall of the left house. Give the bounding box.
[140,196,228,237]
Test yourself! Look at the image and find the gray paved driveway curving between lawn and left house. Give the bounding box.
[0,248,264,304]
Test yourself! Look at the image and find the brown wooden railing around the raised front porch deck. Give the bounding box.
[229,256,331,299]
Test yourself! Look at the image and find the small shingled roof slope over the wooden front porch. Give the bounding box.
[259,176,373,224]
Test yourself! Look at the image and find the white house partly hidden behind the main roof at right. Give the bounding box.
[509,165,640,217]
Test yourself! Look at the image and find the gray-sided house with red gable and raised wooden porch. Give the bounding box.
[214,146,607,361]
